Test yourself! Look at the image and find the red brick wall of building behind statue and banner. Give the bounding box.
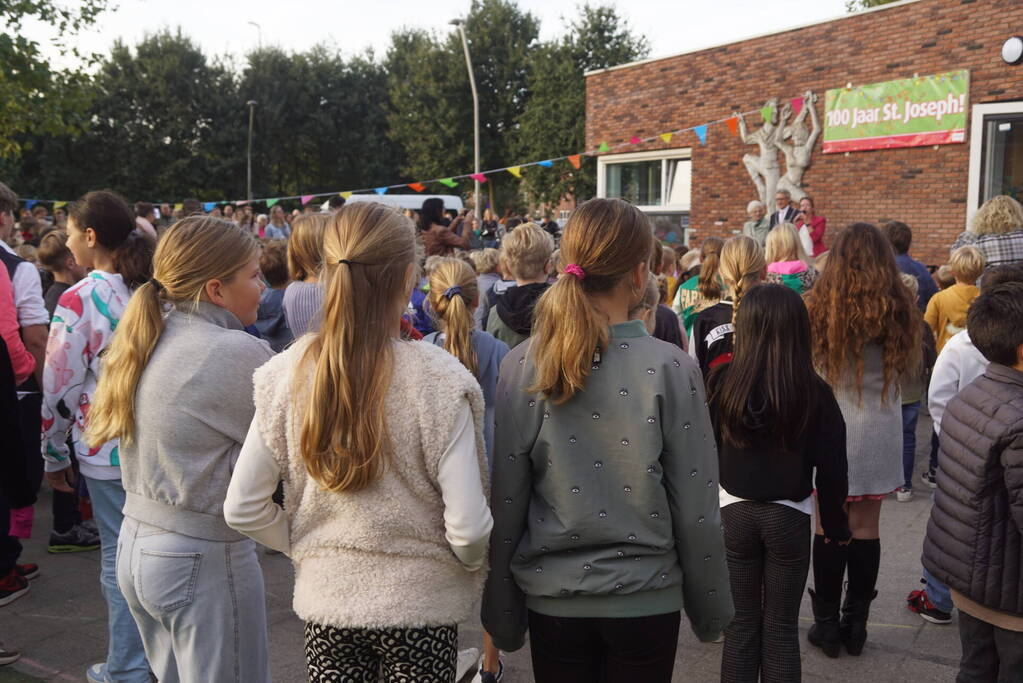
[586,0,1023,264]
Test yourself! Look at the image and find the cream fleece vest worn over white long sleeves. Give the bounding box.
[255,342,489,628]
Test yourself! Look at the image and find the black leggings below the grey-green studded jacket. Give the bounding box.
[529,610,681,683]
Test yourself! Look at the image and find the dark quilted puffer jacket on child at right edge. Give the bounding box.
[924,363,1023,616]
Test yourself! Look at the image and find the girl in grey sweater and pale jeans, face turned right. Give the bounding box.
[87,216,273,682]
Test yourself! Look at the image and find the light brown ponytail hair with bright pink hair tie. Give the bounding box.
[527,194,654,403]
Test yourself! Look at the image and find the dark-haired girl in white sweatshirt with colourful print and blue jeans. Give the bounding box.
[42,191,153,682]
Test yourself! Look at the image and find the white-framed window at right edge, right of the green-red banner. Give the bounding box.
[967,102,1023,219]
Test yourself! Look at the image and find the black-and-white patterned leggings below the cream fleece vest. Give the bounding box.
[306,623,458,683]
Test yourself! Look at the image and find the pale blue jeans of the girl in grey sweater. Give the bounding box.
[118,517,270,683]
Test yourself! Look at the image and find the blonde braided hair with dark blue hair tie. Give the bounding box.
[430,259,479,375]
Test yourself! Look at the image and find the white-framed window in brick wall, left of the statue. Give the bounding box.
[596,148,693,242]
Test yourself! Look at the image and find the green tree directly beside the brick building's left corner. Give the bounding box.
[517,5,650,203]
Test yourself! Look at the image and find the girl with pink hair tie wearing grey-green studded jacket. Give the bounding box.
[482,199,731,683]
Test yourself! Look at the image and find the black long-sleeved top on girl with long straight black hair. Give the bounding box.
[709,365,850,541]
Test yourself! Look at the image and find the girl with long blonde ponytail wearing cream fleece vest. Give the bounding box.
[225,202,492,683]
